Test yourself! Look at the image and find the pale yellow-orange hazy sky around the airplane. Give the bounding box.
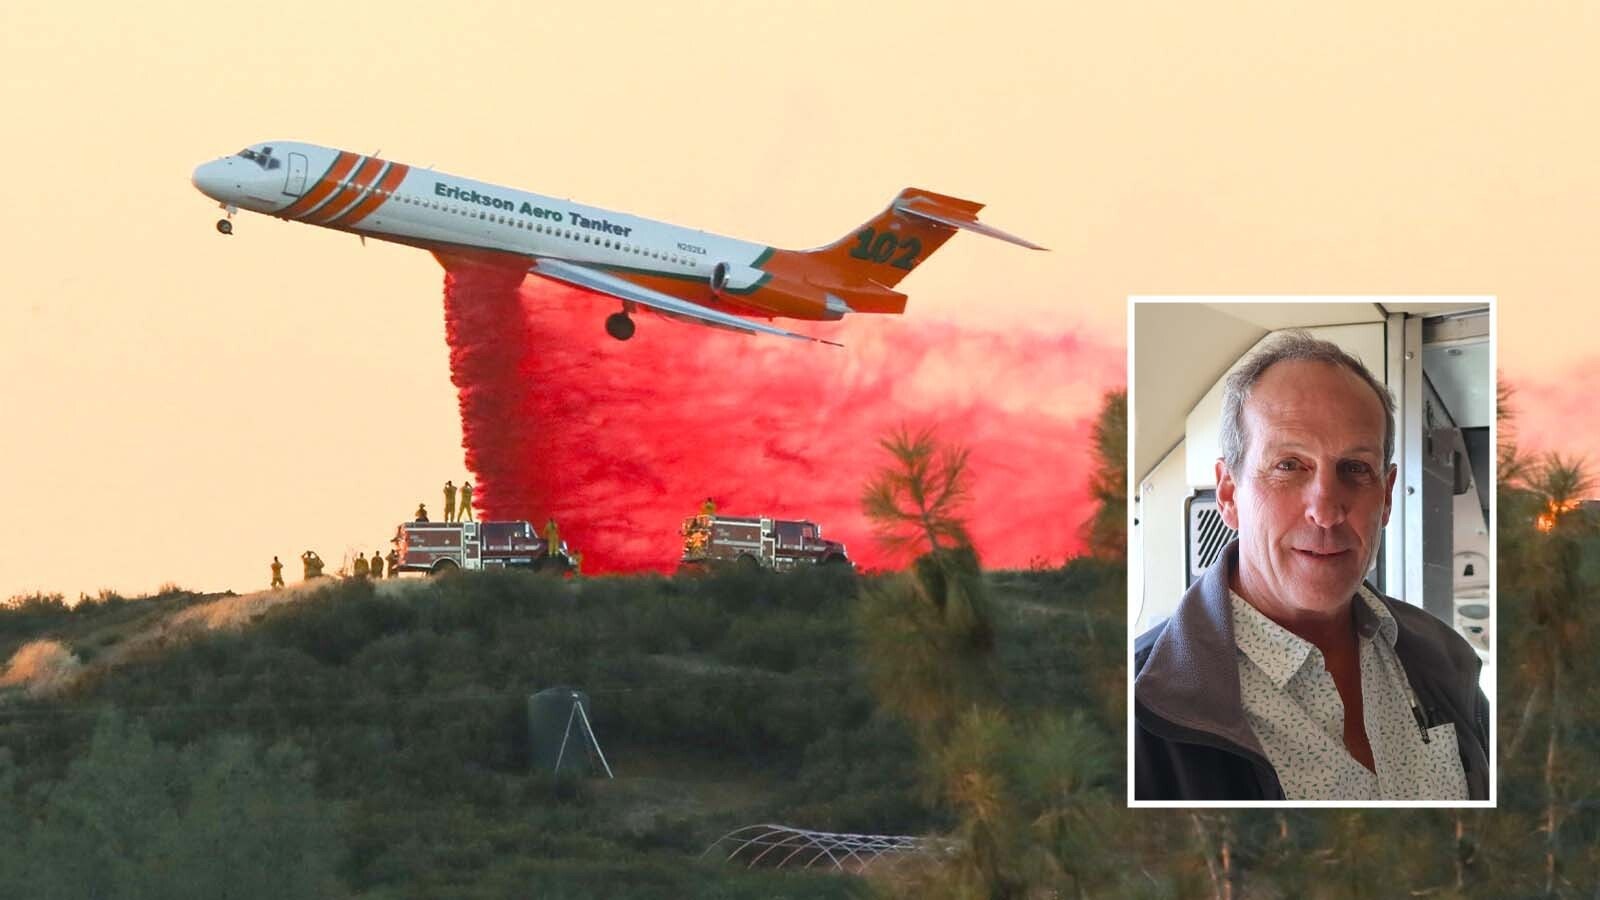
[0,0,1600,597]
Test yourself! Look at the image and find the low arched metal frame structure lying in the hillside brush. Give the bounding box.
[701,823,955,874]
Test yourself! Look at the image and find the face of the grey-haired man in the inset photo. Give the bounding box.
[1216,360,1395,617]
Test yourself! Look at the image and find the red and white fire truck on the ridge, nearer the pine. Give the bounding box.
[680,516,850,572]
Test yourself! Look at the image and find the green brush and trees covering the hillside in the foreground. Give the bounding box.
[9,381,1600,900]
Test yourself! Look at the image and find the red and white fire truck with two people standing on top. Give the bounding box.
[394,522,573,575]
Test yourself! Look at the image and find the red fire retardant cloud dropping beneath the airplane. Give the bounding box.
[445,269,1125,573]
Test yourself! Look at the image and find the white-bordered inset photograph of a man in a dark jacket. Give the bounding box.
[1128,296,1496,806]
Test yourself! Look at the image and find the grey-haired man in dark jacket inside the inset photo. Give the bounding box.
[1134,331,1488,801]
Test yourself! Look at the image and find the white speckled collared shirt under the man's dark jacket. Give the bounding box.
[1229,585,1467,801]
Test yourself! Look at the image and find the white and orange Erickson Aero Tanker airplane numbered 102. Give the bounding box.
[192,141,1045,346]
